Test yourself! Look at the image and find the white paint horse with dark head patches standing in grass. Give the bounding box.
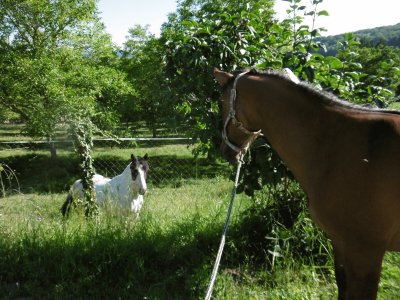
[61,154,149,216]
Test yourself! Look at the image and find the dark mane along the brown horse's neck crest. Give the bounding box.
[234,69,400,115]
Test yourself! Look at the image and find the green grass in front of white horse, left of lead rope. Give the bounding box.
[0,178,252,299]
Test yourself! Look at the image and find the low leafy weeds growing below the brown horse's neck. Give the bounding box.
[232,179,332,269]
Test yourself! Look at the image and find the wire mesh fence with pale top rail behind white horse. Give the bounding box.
[0,138,229,195]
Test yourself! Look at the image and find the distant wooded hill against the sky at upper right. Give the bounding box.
[318,23,400,55]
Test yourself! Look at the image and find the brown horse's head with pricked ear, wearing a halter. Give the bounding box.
[214,68,261,163]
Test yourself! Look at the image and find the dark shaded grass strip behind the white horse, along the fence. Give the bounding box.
[6,153,229,193]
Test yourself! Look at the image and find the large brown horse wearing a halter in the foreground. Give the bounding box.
[214,69,400,300]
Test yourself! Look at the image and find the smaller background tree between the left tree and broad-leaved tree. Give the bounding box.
[121,25,179,137]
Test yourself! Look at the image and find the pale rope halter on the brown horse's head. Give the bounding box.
[222,71,262,154]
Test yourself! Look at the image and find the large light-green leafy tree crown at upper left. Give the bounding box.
[0,0,129,138]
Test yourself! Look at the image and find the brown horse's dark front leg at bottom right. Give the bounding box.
[344,244,385,300]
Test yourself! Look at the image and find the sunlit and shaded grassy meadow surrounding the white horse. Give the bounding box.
[0,123,400,300]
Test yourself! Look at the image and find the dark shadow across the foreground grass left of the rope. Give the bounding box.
[0,210,282,299]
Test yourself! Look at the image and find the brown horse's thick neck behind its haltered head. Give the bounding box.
[246,78,328,190]
